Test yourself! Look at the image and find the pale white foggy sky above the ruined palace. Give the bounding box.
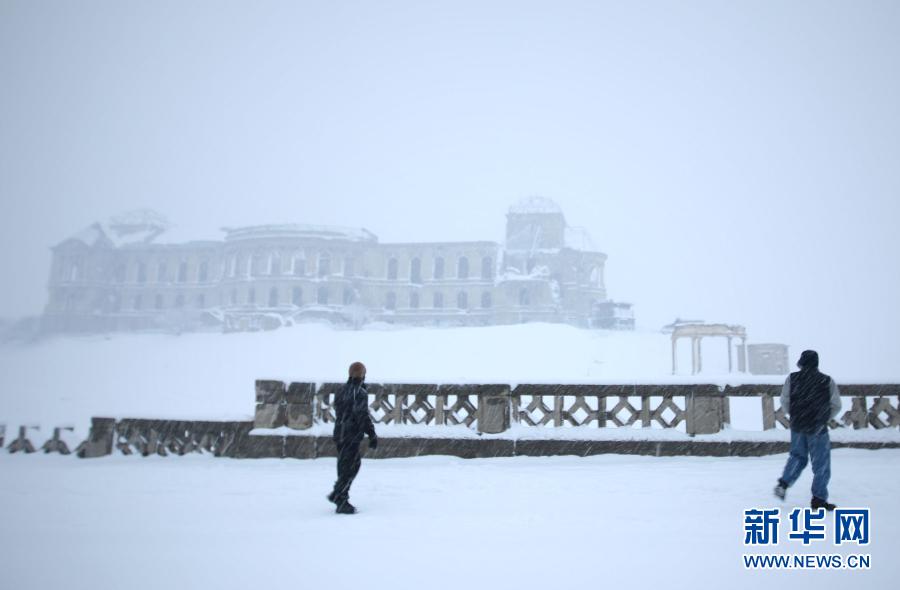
[0,0,900,368]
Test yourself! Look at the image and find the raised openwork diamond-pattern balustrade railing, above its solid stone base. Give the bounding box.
[255,380,900,435]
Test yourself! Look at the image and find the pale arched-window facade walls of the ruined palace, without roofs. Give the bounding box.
[44,209,632,331]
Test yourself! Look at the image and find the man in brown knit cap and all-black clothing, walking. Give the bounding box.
[328,362,378,514]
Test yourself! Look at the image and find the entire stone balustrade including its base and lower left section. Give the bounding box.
[0,380,900,458]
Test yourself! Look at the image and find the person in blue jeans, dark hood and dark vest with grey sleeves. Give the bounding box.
[775,350,841,510]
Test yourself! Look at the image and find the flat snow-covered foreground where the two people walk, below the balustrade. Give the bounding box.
[0,449,900,590]
